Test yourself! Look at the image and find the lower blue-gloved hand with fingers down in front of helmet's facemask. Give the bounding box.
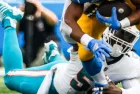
[87,39,112,62]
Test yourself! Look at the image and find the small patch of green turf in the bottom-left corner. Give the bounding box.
[0,77,20,94]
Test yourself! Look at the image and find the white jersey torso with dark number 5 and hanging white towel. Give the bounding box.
[37,52,93,94]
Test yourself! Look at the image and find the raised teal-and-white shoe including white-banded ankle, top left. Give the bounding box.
[0,1,23,28]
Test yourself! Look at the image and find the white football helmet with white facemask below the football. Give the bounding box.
[103,26,139,57]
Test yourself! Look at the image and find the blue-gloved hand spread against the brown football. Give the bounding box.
[96,7,121,30]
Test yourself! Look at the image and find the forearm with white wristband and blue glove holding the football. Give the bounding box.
[96,0,140,30]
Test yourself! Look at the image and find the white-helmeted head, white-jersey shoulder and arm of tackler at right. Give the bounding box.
[93,26,140,94]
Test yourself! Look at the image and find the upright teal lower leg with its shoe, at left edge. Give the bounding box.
[0,1,23,73]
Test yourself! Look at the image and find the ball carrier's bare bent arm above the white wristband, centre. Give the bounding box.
[62,2,84,42]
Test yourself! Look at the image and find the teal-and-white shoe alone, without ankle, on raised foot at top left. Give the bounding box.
[0,1,23,21]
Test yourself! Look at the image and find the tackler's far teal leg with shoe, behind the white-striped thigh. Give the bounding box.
[27,41,68,70]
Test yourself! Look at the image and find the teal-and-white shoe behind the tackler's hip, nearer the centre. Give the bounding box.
[42,40,59,63]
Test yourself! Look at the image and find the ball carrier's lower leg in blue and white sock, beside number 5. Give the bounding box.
[82,57,108,87]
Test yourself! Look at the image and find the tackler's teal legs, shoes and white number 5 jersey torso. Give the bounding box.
[0,1,96,94]
